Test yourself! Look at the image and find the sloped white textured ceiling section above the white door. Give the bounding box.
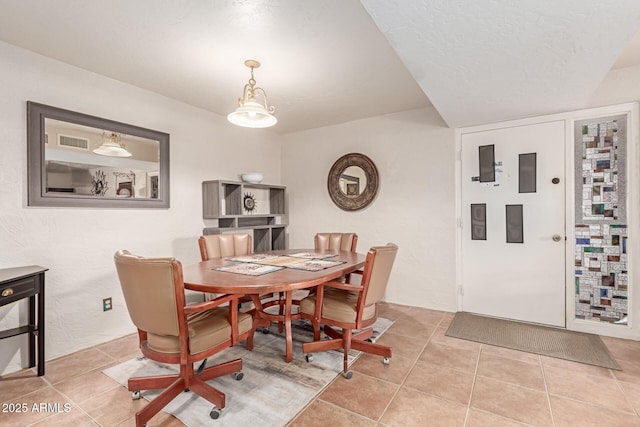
[362,0,640,127]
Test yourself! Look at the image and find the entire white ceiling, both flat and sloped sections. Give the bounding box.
[0,0,640,133]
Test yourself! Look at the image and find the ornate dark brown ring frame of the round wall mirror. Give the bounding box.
[327,153,380,211]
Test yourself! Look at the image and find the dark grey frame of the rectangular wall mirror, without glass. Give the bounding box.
[27,101,170,209]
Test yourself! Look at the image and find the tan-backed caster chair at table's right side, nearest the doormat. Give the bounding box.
[300,243,398,379]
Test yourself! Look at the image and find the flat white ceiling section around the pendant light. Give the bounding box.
[0,0,429,133]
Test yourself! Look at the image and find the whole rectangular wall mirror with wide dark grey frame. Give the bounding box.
[27,101,170,209]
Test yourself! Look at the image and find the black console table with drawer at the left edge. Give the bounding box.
[0,265,48,376]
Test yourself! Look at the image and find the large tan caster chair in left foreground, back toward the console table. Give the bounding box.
[114,250,254,427]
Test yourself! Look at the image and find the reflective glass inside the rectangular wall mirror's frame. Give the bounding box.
[44,118,160,199]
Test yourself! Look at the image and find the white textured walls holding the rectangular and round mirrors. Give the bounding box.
[0,42,640,375]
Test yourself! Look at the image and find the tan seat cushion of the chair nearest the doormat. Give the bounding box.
[300,287,376,323]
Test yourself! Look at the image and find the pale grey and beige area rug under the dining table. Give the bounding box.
[103,318,393,427]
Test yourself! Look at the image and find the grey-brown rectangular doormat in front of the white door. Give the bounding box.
[445,312,622,370]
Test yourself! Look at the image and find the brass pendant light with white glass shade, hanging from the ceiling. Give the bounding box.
[227,59,278,128]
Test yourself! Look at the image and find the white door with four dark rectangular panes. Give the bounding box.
[461,121,566,327]
